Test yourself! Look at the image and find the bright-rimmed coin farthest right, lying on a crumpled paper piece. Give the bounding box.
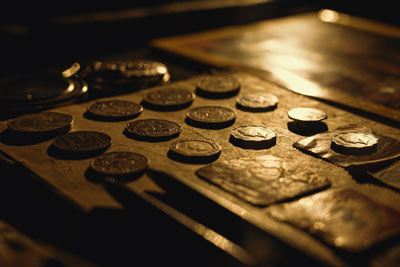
[331,132,378,154]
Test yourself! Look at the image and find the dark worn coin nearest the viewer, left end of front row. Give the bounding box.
[90,152,149,176]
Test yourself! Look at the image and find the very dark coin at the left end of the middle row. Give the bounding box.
[53,131,111,153]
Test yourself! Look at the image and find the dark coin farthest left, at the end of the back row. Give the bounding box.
[7,112,73,134]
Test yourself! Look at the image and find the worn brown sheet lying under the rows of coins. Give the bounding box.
[0,72,400,265]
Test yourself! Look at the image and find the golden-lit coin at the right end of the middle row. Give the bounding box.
[236,93,279,111]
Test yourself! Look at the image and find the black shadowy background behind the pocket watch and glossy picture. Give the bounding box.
[0,0,400,77]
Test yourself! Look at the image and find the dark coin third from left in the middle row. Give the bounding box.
[186,106,236,128]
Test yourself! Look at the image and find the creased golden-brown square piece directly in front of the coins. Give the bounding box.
[196,155,330,206]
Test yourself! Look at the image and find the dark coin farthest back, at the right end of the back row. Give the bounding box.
[196,75,240,97]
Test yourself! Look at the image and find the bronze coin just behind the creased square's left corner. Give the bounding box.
[170,139,221,157]
